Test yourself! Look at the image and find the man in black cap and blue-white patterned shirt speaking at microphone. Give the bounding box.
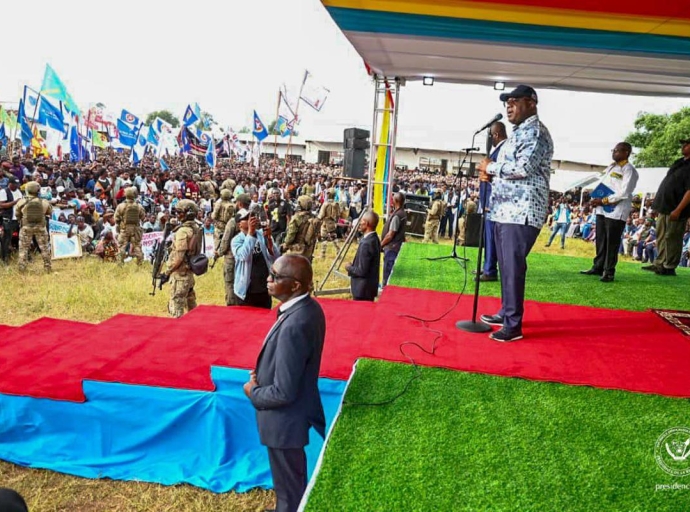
[477,85,553,342]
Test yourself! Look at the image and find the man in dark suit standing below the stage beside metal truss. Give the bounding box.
[345,211,381,301]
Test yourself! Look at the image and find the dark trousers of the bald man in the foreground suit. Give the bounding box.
[268,448,307,512]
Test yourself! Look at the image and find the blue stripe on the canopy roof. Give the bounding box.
[328,7,690,59]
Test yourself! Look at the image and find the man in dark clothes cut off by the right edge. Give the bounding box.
[642,138,690,276]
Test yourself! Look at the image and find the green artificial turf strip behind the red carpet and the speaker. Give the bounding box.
[390,243,690,311]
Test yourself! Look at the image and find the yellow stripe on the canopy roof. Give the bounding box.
[324,0,690,37]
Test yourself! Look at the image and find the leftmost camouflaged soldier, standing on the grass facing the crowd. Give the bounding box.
[15,181,53,272]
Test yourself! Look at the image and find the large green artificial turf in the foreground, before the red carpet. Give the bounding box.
[307,360,690,512]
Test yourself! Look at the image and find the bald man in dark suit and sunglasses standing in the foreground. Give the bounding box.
[244,254,326,512]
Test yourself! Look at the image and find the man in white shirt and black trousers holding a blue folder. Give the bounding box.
[580,142,638,283]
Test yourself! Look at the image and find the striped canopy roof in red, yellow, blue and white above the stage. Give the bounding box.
[322,0,690,96]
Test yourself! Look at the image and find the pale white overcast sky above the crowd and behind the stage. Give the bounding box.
[0,0,690,164]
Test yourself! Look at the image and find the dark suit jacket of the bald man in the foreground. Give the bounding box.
[250,297,326,449]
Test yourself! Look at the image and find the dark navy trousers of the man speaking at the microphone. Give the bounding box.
[494,222,539,334]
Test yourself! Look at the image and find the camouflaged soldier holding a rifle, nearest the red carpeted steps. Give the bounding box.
[166,199,201,318]
